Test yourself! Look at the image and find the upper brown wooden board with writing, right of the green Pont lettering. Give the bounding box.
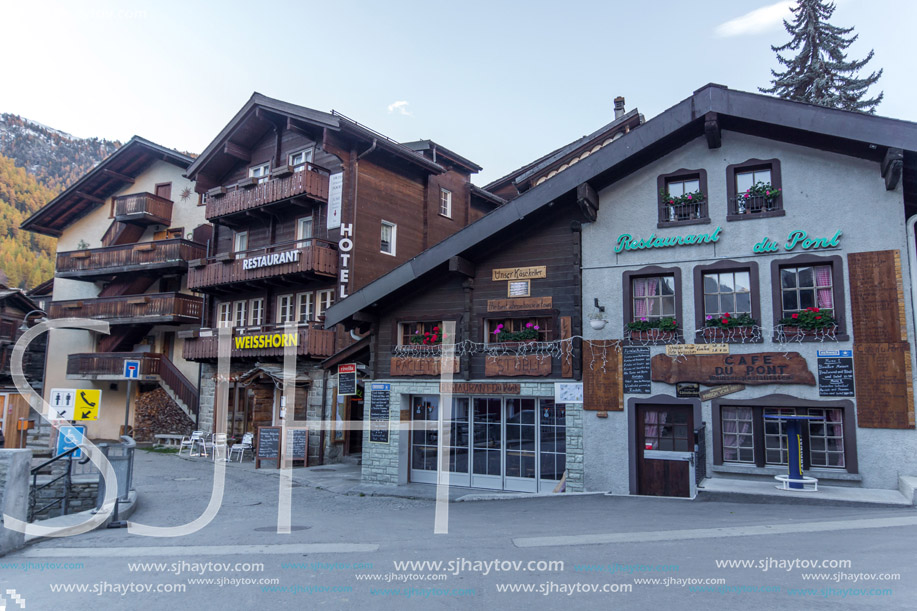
[847,250,907,343]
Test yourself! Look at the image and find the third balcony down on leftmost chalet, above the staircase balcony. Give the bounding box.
[48,293,204,325]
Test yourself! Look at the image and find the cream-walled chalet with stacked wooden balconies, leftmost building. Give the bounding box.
[22,136,211,439]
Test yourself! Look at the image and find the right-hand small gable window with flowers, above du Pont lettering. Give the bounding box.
[726,159,786,221]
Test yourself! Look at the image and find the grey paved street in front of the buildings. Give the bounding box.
[0,452,917,610]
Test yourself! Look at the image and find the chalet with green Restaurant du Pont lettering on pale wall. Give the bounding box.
[326,85,917,496]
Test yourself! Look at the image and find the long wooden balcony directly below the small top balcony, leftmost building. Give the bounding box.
[57,238,207,279]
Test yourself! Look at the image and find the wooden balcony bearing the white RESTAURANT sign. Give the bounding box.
[188,239,338,291]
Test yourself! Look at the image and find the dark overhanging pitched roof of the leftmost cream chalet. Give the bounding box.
[20,136,192,238]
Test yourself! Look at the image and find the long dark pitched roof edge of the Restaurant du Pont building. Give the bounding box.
[325,84,917,328]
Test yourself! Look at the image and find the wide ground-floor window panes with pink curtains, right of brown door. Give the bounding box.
[713,402,857,473]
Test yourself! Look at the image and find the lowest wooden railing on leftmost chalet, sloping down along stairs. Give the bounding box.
[67,352,199,413]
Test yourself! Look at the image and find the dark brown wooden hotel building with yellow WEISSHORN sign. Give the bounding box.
[183,93,494,463]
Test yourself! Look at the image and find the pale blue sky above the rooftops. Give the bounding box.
[0,0,917,184]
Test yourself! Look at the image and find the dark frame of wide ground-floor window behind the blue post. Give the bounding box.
[711,394,859,475]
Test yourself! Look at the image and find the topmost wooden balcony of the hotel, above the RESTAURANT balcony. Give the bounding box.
[206,164,328,220]
